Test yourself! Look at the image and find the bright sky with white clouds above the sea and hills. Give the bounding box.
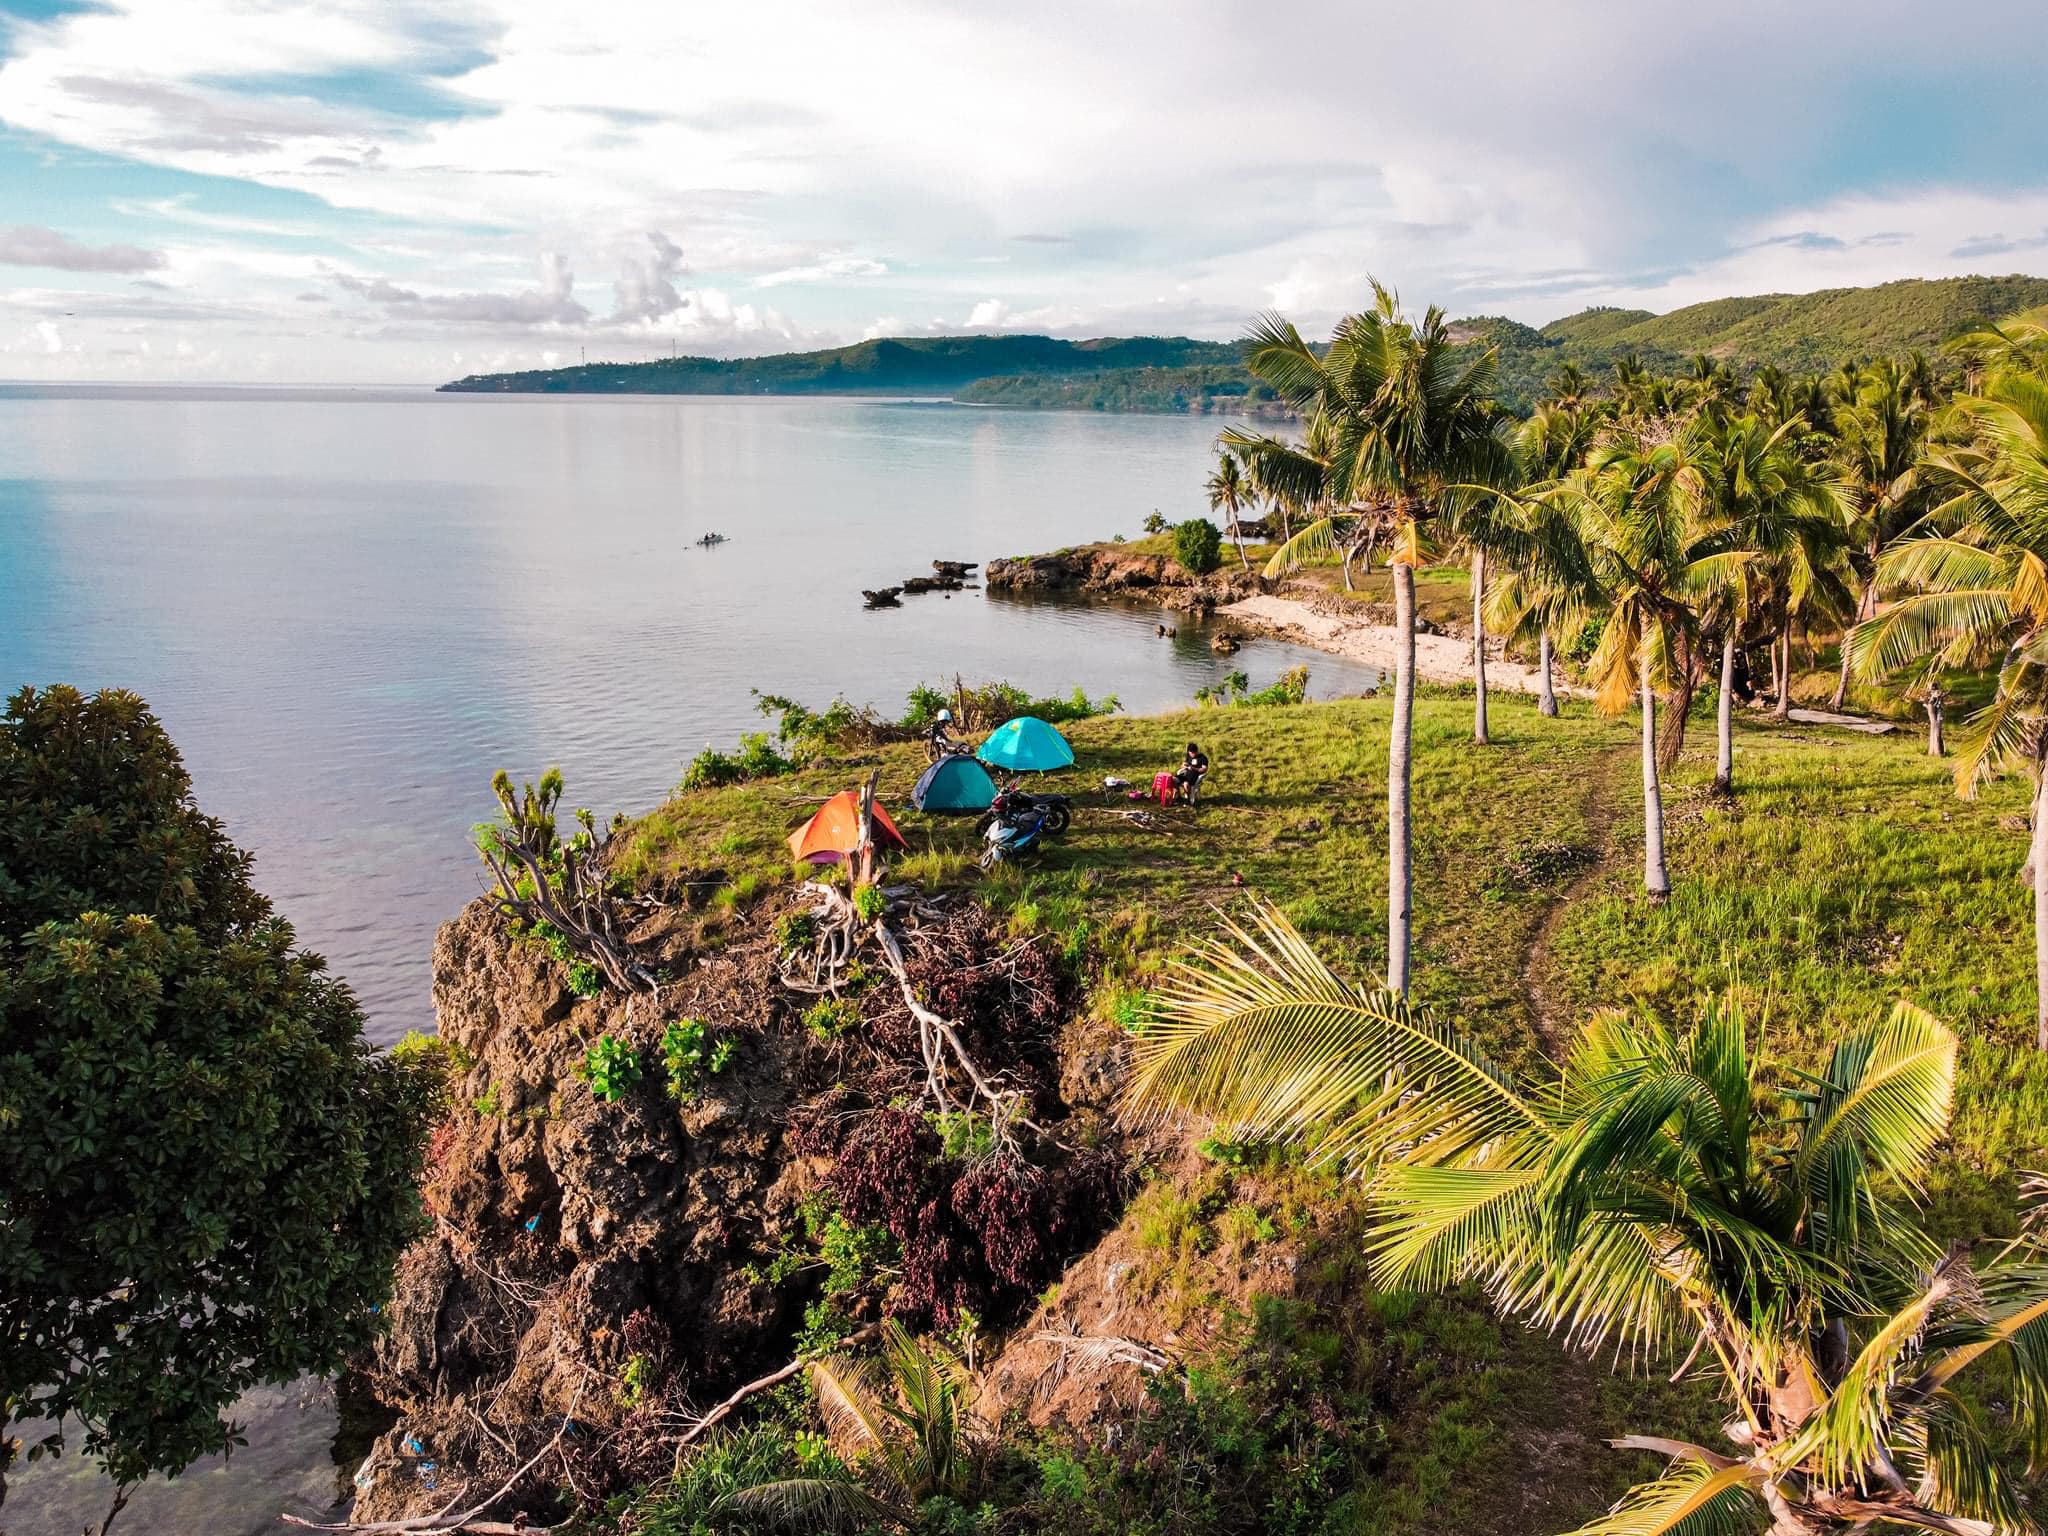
[0,0,2048,383]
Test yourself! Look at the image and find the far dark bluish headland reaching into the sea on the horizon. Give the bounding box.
[442,336,1237,395]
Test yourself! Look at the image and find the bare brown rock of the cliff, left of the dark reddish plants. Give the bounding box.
[344,901,815,1520]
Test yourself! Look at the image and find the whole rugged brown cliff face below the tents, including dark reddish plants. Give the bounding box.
[354,899,1122,1520]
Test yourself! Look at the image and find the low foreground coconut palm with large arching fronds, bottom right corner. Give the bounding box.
[1126,907,2048,1536]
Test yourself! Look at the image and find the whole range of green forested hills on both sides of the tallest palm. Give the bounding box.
[442,276,2048,412]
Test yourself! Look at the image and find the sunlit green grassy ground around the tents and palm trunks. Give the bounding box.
[631,694,2048,1536]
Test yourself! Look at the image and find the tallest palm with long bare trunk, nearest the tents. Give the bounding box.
[1243,283,1507,991]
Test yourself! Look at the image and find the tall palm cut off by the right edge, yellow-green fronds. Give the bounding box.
[1849,369,2048,1051]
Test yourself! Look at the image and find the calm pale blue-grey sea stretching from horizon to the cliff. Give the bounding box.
[0,387,1372,1042]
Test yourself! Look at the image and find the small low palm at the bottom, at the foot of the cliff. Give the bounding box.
[731,1319,973,1530]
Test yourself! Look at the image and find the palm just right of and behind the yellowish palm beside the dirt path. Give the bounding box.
[1688,414,1847,791]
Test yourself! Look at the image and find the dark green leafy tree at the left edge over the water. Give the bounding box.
[0,688,432,1507]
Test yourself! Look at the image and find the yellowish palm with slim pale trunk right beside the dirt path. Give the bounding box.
[1544,432,1700,901]
